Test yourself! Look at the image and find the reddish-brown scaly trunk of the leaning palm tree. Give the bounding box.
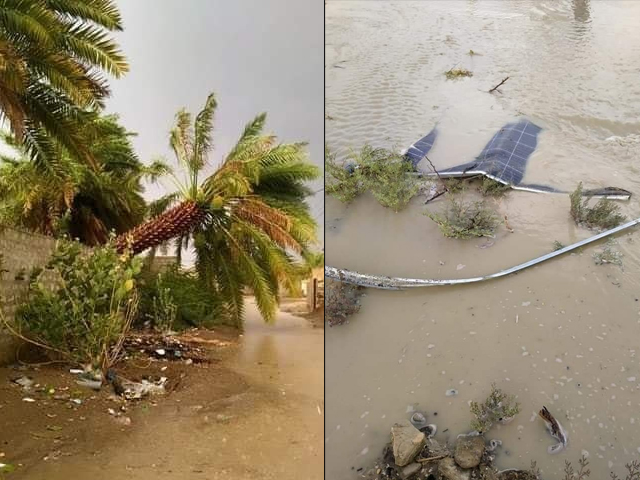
[116,200,206,255]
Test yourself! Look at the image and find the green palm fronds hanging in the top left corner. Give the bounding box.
[0,0,128,164]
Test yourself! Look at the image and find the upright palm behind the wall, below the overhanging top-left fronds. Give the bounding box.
[0,115,167,245]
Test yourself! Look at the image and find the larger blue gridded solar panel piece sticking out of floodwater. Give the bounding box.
[439,120,541,185]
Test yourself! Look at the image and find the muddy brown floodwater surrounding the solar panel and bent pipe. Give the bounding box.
[325,0,640,480]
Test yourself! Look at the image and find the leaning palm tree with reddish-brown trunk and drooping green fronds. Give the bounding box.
[117,94,319,325]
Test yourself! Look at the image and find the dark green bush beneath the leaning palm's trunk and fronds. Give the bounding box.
[138,265,234,331]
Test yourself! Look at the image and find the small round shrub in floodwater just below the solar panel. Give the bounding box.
[425,199,499,239]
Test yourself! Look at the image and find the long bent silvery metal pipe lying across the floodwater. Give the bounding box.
[324,218,640,290]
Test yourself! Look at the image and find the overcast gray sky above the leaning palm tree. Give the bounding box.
[107,0,324,248]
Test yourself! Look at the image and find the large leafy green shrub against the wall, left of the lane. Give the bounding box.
[3,240,142,371]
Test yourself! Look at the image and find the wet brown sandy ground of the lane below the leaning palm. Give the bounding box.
[0,304,324,480]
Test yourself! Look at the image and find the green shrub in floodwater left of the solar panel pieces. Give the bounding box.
[325,145,423,212]
